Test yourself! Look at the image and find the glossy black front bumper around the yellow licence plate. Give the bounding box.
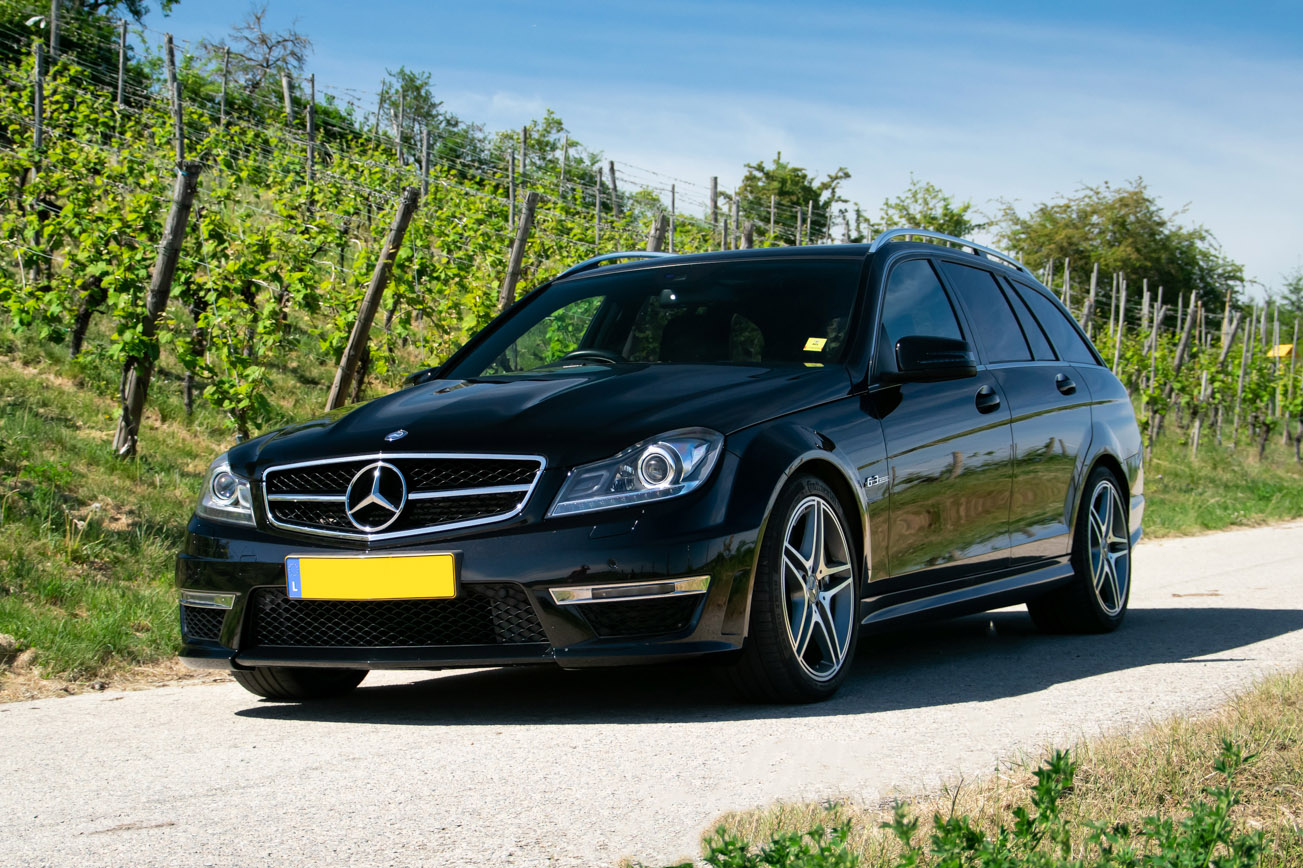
[176,482,757,669]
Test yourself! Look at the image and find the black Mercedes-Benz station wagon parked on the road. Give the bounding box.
[177,229,1144,701]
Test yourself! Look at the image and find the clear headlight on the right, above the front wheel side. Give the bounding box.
[547,427,724,515]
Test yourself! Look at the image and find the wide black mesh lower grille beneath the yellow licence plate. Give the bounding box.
[249,584,547,648]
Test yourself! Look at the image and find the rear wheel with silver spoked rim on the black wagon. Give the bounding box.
[1027,467,1131,633]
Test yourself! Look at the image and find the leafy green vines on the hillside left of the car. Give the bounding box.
[0,10,710,445]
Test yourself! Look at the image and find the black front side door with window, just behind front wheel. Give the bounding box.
[869,258,1012,590]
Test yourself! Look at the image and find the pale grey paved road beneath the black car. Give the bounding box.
[0,523,1303,867]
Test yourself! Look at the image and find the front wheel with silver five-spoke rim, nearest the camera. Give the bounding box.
[726,476,861,702]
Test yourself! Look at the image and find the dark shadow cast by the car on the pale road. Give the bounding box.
[236,607,1303,726]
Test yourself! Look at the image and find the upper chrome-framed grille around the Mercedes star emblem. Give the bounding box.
[263,455,543,540]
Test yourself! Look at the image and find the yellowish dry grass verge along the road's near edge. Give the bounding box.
[704,671,1303,868]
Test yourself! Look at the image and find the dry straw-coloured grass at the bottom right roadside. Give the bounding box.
[703,673,1303,868]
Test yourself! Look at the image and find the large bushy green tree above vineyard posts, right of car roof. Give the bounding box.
[998,179,1244,311]
